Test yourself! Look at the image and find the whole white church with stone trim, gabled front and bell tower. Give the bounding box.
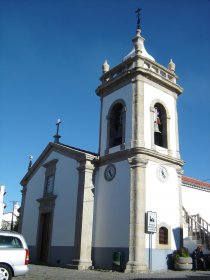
[19,14,210,272]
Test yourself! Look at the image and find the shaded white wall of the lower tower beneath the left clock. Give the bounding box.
[93,161,130,247]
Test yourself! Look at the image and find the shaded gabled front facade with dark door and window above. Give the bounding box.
[21,144,96,265]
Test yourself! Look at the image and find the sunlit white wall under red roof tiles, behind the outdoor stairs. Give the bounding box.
[182,186,210,224]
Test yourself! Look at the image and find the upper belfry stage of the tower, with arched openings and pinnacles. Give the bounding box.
[96,25,183,158]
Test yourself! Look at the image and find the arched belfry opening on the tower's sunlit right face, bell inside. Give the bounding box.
[154,103,168,149]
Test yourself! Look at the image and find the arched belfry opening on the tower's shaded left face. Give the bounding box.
[108,101,125,148]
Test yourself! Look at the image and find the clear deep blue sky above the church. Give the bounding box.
[0,0,210,210]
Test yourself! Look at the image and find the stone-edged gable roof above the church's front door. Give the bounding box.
[20,142,98,186]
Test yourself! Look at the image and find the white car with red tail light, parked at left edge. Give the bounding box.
[0,230,29,280]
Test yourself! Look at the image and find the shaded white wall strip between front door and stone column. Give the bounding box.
[52,155,78,246]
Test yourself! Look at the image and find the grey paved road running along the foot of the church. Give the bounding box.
[14,265,210,280]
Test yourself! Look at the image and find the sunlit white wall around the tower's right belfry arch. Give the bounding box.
[144,83,178,157]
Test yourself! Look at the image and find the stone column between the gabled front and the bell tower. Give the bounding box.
[69,159,94,270]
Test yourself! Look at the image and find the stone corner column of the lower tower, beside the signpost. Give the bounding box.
[126,155,148,272]
